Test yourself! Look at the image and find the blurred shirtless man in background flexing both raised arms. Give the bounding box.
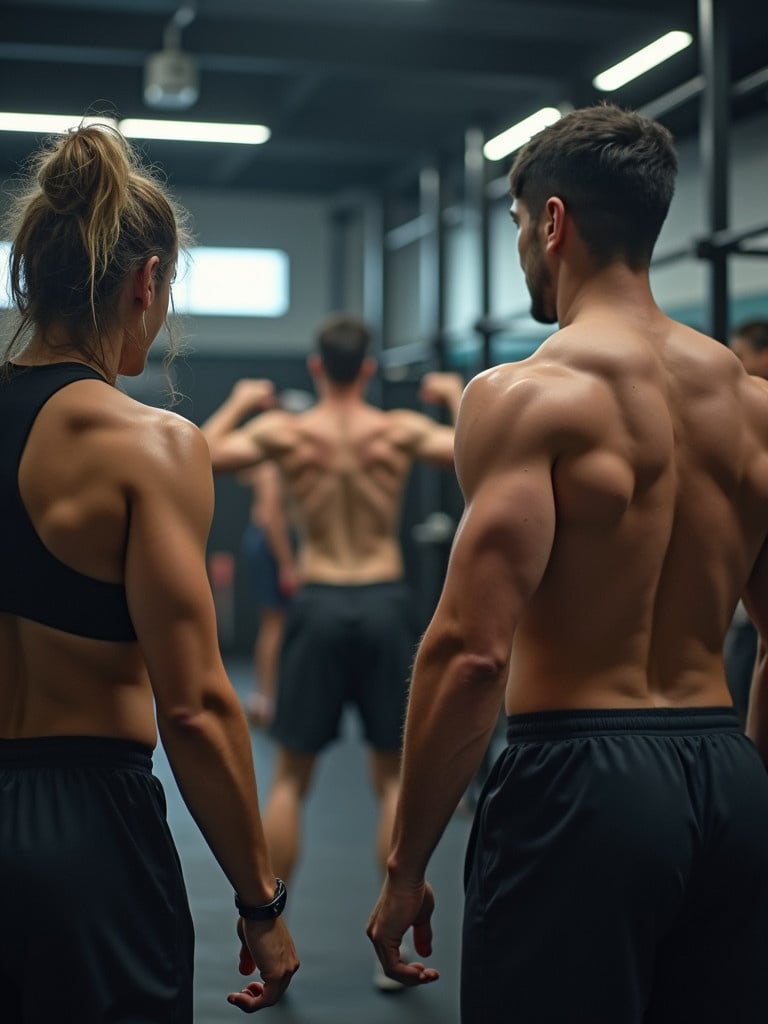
[202,315,463,954]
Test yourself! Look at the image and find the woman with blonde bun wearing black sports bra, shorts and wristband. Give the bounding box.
[0,119,299,1024]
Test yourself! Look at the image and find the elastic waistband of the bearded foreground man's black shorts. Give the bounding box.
[507,707,742,743]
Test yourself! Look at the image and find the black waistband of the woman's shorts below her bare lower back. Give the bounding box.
[0,736,153,772]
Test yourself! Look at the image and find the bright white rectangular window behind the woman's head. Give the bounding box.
[0,242,290,316]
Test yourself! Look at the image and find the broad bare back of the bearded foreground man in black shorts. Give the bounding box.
[462,317,768,711]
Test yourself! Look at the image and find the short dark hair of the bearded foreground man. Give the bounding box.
[510,103,677,269]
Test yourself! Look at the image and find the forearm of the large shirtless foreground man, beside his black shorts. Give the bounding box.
[388,633,506,884]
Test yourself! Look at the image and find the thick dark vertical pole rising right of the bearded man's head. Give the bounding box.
[698,0,730,342]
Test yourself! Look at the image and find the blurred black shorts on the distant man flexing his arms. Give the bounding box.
[270,582,416,754]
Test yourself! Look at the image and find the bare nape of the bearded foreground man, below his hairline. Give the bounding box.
[557,263,658,327]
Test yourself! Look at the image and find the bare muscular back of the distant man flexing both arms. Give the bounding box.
[256,400,434,584]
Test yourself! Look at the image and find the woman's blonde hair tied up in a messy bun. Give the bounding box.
[2,124,189,389]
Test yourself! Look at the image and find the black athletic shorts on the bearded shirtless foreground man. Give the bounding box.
[462,708,768,1024]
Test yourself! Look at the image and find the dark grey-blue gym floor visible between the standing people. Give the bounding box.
[155,662,471,1024]
